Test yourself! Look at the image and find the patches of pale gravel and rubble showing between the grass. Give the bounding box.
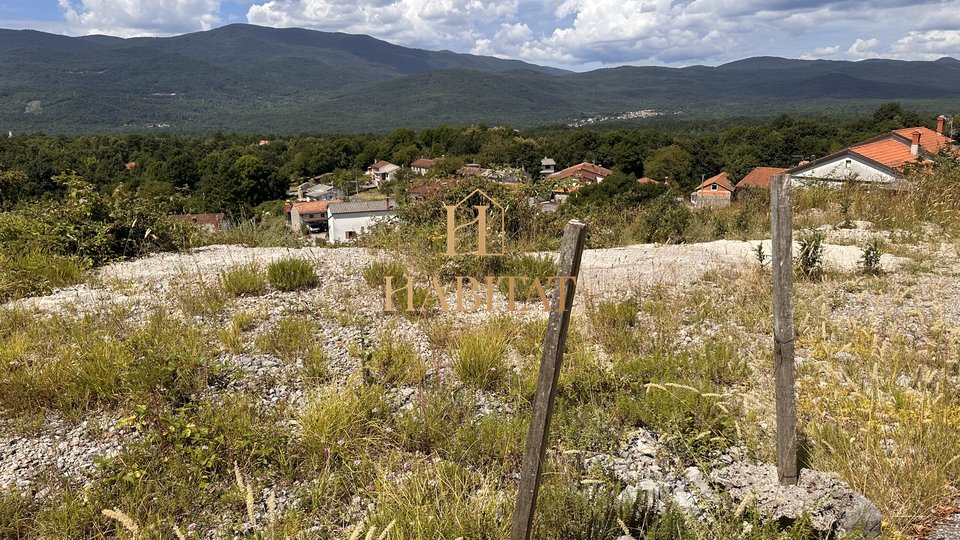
[0,227,960,539]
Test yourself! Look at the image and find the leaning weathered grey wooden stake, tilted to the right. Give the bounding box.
[510,221,586,540]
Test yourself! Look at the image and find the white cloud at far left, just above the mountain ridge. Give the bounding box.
[58,0,220,37]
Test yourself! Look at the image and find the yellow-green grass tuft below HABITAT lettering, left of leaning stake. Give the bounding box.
[453,325,508,390]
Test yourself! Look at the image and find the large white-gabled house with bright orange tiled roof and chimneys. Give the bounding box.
[785,115,956,188]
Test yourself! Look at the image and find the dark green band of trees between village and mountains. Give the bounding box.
[0,103,934,215]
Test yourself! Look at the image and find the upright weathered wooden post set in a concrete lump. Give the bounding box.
[770,174,797,486]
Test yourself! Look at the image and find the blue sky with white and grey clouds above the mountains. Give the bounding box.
[0,0,960,71]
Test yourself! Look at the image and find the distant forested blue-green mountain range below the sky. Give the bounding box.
[0,25,960,133]
